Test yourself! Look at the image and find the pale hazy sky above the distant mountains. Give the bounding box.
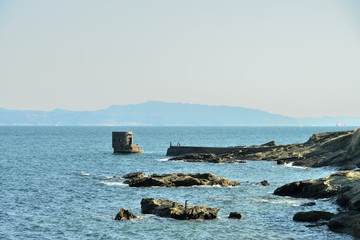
[0,0,360,117]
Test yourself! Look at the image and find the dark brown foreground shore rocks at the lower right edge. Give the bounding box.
[274,170,360,239]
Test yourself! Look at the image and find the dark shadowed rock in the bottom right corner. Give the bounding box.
[328,211,360,239]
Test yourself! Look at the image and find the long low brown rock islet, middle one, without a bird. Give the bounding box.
[125,173,240,187]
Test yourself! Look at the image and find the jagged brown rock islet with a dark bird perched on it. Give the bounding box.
[141,198,220,220]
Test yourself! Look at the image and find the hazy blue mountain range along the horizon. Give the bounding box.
[0,101,360,126]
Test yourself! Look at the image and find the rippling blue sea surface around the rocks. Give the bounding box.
[0,126,354,239]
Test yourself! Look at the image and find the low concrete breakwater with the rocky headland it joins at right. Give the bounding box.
[168,128,360,170]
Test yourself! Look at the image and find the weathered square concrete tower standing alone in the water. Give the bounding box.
[112,132,144,153]
